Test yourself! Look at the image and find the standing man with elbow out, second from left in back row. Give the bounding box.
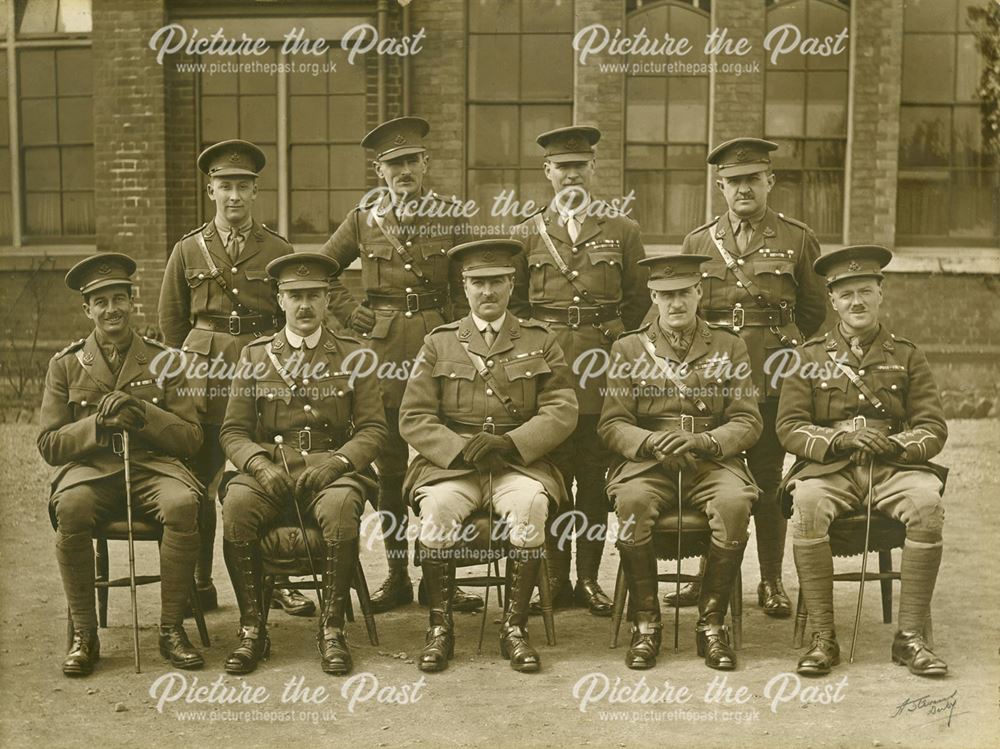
[320,117,482,613]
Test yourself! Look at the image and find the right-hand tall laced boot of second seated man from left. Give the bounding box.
[316,536,358,676]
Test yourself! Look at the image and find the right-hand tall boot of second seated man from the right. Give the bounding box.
[696,543,746,671]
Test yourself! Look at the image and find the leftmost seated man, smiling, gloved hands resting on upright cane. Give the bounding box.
[38,252,204,676]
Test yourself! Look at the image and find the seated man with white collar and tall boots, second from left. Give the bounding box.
[220,252,387,675]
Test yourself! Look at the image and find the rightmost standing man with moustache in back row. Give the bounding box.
[664,138,826,617]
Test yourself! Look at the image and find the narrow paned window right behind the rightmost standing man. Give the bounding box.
[764,0,850,241]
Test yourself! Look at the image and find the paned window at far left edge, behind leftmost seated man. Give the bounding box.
[0,0,95,245]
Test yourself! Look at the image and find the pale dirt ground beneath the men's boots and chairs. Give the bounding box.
[0,419,1000,748]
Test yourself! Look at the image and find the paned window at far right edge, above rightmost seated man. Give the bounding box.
[896,0,1000,246]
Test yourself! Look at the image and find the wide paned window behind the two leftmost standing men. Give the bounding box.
[199,44,366,243]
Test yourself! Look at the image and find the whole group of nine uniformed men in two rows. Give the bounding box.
[38,117,947,675]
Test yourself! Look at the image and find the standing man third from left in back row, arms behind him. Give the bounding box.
[511,127,649,616]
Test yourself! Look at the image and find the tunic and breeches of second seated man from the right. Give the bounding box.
[598,319,761,546]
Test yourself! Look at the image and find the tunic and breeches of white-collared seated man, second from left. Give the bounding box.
[220,329,387,541]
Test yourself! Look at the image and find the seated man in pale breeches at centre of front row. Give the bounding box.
[399,240,577,671]
